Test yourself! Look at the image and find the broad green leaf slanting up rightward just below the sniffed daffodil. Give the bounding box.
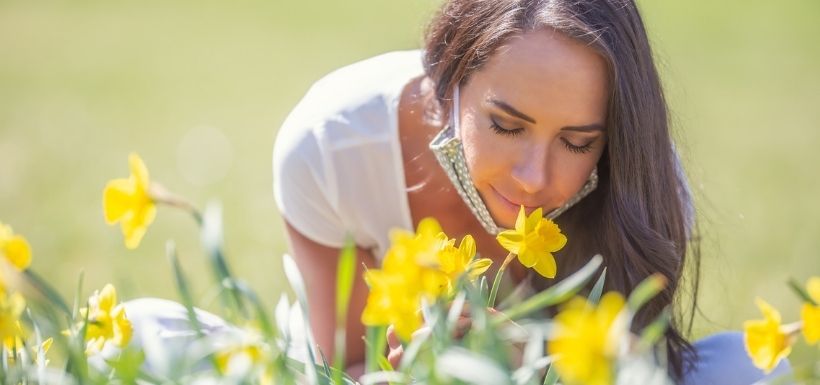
[493,255,603,324]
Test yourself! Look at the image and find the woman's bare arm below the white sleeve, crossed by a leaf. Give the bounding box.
[286,221,377,378]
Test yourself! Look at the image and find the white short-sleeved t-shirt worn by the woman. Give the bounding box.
[273,50,424,259]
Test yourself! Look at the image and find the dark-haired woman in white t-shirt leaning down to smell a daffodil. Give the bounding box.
[274,0,796,384]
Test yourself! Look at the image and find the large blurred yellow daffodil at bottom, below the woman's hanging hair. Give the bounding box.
[547,292,628,385]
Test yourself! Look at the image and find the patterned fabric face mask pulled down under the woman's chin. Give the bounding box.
[429,86,598,235]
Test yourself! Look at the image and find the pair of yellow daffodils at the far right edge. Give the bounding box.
[743,277,820,373]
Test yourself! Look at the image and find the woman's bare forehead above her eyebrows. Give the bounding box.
[469,29,609,124]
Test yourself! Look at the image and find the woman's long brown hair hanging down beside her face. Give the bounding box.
[424,0,700,379]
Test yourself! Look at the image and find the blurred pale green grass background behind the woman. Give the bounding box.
[0,0,820,360]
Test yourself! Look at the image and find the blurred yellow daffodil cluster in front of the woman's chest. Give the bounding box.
[362,218,491,340]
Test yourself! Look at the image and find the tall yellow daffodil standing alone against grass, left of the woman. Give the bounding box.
[103,153,156,249]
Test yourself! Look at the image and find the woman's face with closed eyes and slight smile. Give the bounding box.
[460,29,608,228]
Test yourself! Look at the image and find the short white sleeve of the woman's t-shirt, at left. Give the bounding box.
[273,122,346,247]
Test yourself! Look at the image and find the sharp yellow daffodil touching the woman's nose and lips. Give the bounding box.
[496,206,567,278]
